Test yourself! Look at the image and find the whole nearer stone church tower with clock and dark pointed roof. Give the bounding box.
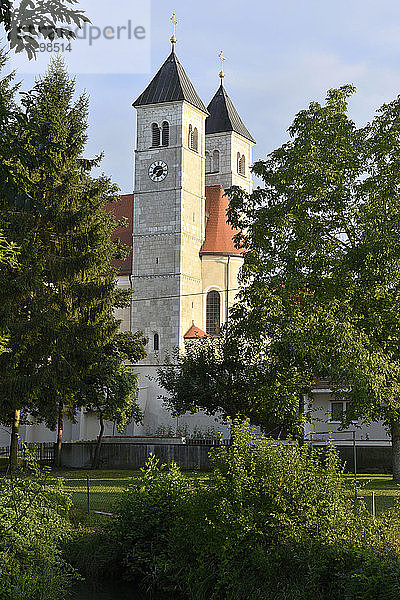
[131,19,208,432]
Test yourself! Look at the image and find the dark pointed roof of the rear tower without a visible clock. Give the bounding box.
[206,82,255,143]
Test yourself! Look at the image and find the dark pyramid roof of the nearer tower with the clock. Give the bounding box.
[133,50,208,114]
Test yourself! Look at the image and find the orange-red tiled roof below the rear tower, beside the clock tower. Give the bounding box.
[200,185,243,254]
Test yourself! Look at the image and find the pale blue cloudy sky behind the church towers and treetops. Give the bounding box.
[6,0,400,193]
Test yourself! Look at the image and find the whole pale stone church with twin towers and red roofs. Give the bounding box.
[5,22,389,446]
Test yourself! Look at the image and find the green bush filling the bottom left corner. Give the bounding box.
[0,454,75,600]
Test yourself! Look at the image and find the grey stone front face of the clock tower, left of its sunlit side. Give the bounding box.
[131,103,187,356]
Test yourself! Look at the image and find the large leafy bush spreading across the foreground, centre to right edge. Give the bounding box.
[111,422,400,600]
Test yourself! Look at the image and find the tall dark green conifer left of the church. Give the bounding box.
[0,60,146,468]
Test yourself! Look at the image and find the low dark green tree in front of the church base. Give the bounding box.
[158,326,308,433]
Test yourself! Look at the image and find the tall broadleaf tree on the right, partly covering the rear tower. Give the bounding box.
[230,86,400,480]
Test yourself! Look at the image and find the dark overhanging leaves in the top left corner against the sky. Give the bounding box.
[0,0,90,59]
